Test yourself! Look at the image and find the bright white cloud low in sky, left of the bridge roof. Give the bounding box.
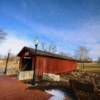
[0,36,32,55]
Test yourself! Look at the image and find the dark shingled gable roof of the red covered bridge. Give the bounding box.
[17,47,75,60]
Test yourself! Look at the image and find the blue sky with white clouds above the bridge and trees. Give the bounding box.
[0,0,100,59]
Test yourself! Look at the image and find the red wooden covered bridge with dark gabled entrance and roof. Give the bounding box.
[18,47,77,76]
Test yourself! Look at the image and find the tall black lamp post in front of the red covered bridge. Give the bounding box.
[32,40,38,85]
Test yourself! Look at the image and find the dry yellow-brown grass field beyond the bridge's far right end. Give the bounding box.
[78,63,100,73]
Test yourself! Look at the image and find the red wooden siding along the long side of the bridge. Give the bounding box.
[37,56,77,75]
